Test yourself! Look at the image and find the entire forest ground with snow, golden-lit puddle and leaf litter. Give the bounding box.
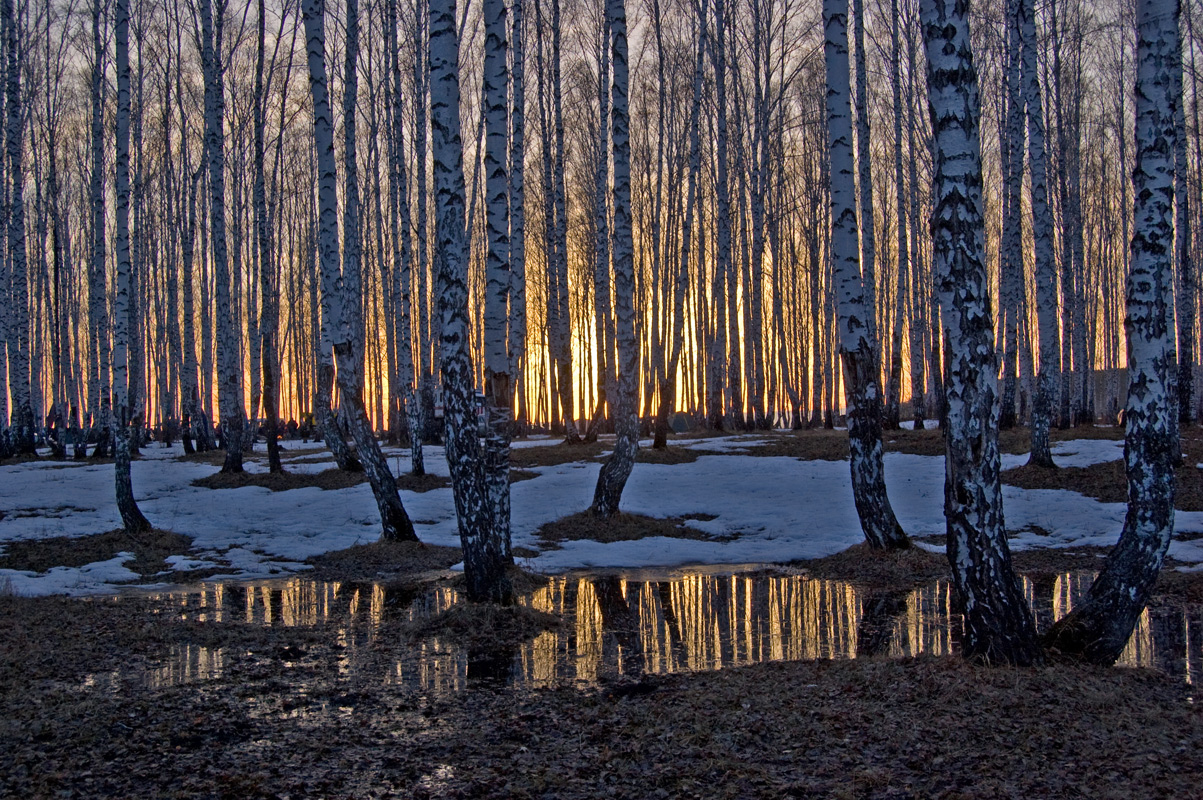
[0,427,1203,799]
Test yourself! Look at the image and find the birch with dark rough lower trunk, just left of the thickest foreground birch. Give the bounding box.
[823,0,909,549]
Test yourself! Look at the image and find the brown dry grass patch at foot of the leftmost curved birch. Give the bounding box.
[0,529,192,577]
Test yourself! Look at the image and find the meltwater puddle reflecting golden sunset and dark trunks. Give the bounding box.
[124,573,1203,693]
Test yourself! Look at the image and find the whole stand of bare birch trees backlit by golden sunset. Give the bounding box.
[0,0,1203,644]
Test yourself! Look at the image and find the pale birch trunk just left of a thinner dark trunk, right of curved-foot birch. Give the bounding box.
[201,0,244,473]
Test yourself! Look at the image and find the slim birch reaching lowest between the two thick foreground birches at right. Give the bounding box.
[1020,0,1061,468]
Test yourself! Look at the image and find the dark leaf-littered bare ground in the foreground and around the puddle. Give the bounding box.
[0,545,1203,800]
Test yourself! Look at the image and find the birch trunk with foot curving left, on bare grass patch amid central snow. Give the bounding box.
[592,0,639,518]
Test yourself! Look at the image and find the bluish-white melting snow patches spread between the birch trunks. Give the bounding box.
[0,437,1203,594]
